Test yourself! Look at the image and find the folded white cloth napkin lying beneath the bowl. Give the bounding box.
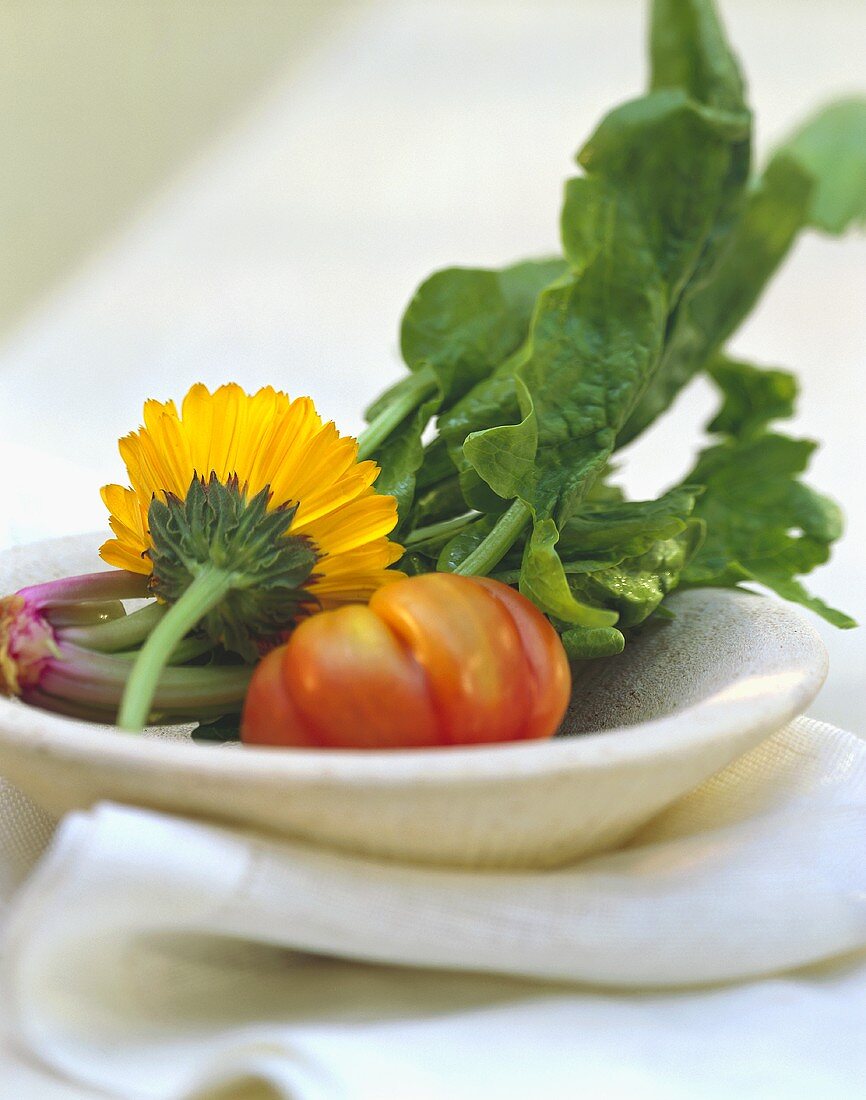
[0,718,866,1100]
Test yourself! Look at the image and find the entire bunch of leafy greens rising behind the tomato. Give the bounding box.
[360,0,866,658]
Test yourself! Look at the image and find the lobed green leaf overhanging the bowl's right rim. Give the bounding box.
[683,433,854,627]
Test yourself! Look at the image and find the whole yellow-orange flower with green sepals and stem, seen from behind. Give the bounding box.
[100,385,403,729]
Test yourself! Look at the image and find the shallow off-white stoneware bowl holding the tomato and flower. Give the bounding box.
[0,536,826,867]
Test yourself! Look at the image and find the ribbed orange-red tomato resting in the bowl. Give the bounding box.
[241,573,571,749]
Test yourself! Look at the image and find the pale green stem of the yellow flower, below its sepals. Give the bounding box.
[118,567,235,733]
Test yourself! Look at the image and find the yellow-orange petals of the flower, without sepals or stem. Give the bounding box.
[100,384,403,608]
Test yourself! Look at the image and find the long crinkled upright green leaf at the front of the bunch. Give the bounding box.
[463,32,748,626]
